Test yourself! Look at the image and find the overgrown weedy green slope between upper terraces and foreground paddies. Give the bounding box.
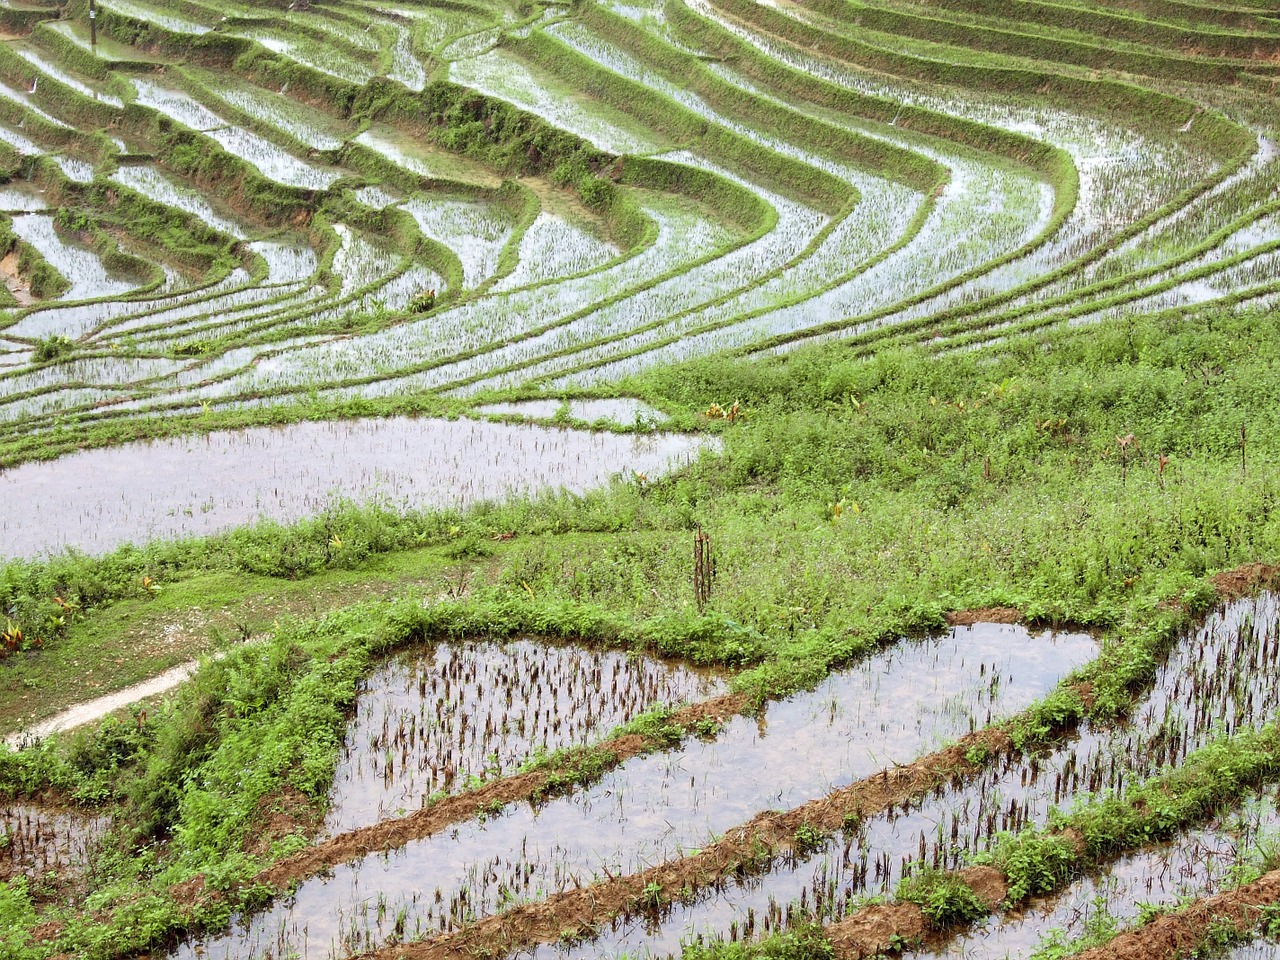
[0,300,1280,956]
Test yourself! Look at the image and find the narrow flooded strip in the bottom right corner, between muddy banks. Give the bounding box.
[904,785,1280,960]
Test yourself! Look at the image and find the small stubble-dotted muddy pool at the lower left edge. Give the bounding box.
[0,804,111,881]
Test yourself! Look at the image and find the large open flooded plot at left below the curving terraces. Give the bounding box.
[0,417,714,559]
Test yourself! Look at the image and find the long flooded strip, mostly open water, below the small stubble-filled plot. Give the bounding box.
[165,625,1096,960]
